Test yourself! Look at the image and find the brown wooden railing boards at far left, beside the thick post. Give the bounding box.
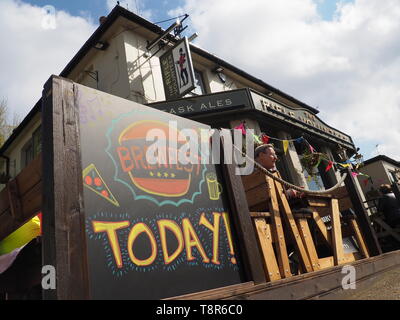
[0,154,42,240]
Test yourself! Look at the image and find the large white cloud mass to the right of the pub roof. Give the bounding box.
[170,0,400,160]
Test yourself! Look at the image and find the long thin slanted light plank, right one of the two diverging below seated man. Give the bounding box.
[273,181,313,272]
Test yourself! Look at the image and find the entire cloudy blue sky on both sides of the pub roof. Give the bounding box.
[0,0,400,161]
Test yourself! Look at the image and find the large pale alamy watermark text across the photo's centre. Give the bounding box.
[138,121,255,175]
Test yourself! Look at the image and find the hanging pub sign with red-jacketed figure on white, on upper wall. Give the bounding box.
[160,37,195,100]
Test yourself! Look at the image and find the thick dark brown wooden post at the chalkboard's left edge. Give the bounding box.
[42,76,89,299]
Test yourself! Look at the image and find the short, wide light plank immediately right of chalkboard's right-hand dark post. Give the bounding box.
[254,218,281,281]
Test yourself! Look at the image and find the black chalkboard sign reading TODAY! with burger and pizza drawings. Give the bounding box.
[75,85,244,299]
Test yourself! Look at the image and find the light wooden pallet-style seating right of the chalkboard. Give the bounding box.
[242,171,369,281]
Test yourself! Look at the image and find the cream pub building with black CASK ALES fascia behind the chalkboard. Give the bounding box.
[0,6,384,297]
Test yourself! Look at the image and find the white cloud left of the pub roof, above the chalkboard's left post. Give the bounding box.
[0,0,95,122]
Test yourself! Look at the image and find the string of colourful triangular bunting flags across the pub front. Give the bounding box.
[234,121,372,185]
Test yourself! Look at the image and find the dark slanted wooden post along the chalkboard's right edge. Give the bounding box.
[221,141,266,284]
